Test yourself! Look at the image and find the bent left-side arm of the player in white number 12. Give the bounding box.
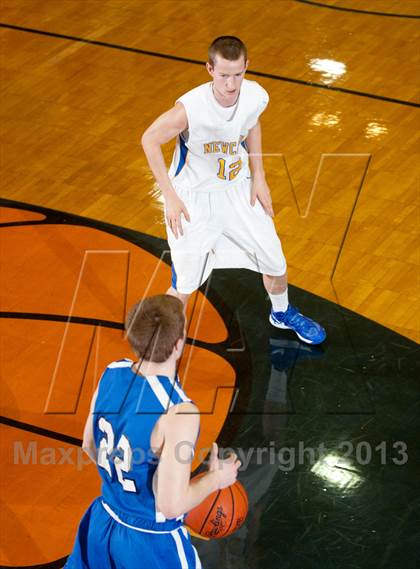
[141,103,190,237]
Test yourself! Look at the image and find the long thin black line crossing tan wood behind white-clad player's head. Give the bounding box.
[0,23,420,107]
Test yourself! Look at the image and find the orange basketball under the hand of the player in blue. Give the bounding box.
[184,473,248,539]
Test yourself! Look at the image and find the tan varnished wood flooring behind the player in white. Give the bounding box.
[0,0,420,340]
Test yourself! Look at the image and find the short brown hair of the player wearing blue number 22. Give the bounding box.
[125,294,185,363]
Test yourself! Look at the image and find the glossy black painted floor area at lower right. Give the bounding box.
[202,271,420,569]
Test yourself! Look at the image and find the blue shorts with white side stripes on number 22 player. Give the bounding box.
[64,498,201,569]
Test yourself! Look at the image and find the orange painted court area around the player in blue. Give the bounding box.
[0,216,236,566]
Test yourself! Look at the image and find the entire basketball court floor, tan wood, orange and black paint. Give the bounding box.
[0,0,420,569]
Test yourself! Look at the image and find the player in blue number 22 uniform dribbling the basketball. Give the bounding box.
[65,295,240,569]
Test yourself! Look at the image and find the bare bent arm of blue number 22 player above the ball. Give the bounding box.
[156,403,240,519]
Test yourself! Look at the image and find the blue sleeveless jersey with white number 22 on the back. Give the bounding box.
[93,359,190,531]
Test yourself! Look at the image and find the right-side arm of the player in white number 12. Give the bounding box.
[246,121,274,217]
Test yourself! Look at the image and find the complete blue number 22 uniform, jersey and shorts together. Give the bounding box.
[65,359,201,569]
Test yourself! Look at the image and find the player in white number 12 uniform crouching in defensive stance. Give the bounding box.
[142,36,326,344]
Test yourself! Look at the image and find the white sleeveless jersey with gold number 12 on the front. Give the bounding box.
[169,79,269,191]
